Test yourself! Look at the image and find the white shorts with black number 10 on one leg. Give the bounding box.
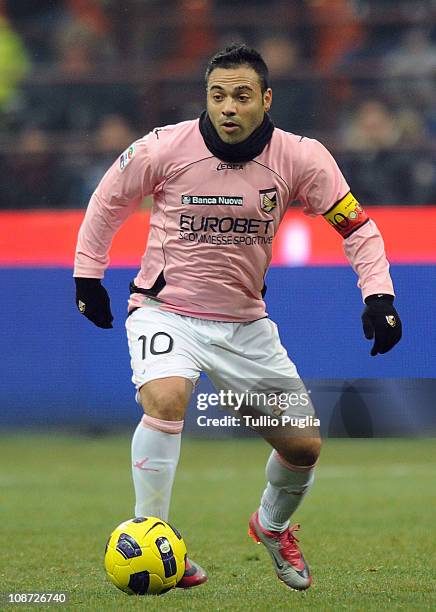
[126,299,314,417]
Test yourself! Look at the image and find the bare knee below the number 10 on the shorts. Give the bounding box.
[140,381,189,421]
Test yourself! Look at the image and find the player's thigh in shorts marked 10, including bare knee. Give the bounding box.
[126,307,201,420]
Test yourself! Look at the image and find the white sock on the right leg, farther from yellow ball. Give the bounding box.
[258,450,315,531]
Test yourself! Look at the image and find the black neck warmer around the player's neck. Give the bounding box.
[200,111,274,163]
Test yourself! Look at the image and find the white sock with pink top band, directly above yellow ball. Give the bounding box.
[132,415,183,521]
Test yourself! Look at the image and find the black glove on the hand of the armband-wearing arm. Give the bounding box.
[362,293,402,357]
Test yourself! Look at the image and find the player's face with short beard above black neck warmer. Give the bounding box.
[207,65,272,144]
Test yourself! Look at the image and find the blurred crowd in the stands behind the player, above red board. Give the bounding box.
[0,0,436,209]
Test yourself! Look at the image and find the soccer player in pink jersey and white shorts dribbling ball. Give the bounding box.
[74,45,401,590]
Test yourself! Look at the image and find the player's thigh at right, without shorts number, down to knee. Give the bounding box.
[208,319,320,465]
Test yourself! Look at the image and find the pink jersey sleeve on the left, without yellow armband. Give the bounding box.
[73,133,161,278]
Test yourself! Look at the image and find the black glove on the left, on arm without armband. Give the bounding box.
[74,278,114,329]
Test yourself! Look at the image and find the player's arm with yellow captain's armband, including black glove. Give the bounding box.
[300,141,402,356]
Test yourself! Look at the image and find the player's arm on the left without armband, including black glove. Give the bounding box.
[73,137,157,328]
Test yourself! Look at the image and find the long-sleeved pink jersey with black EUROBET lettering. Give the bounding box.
[74,119,393,322]
